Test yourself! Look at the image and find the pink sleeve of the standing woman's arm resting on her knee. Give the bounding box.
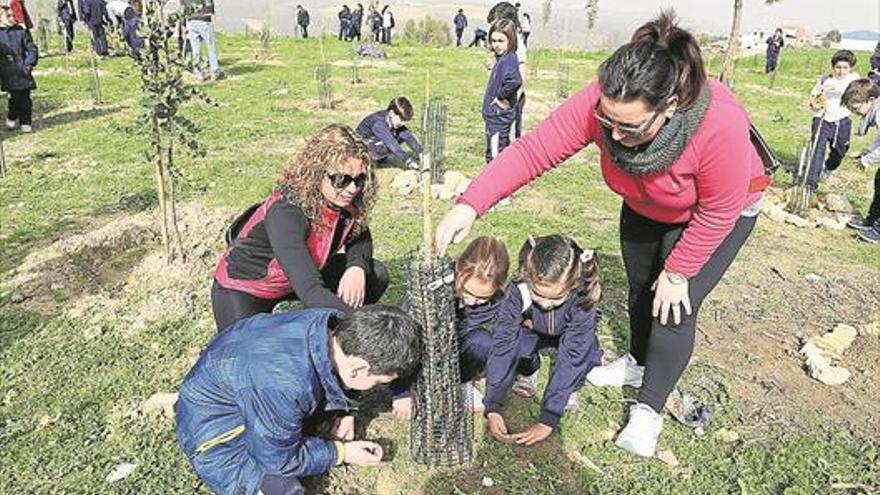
[665,105,752,278]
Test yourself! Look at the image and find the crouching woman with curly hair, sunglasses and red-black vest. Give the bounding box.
[211,124,388,330]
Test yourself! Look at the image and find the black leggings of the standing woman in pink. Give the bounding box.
[620,204,757,412]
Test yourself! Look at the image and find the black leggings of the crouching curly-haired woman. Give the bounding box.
[211,254,389,332]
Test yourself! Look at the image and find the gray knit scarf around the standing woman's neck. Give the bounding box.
[602,84,712,177]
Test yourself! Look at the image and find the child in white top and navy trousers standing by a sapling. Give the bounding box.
[807,50,859,191]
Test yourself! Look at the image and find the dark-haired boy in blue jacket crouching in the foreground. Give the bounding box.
[175,305,419,495]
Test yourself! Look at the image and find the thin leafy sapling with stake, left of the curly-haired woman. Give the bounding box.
[137,0,211,262]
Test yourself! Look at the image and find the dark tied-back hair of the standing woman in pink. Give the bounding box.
[599,10,706,109]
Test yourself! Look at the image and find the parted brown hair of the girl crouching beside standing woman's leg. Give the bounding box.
[517,234,602,309]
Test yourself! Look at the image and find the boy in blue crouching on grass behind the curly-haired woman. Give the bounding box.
[356,96,422,168]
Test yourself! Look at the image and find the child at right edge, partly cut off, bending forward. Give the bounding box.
[841,78,880,243]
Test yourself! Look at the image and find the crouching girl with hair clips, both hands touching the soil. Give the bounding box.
[484,235,602,445]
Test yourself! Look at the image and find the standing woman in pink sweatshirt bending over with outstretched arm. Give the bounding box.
[436,12,769,456]
